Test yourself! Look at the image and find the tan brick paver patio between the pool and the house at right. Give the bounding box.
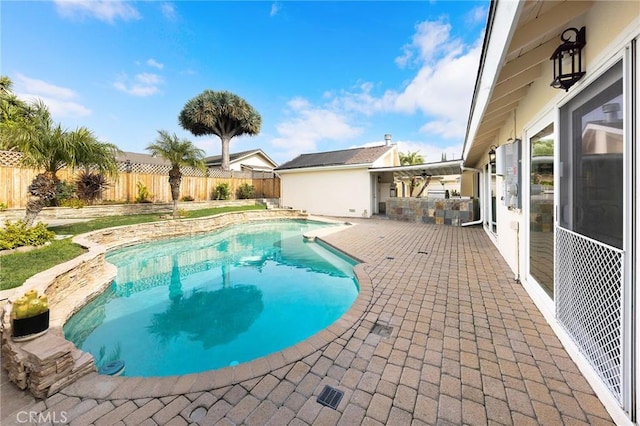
[0,219,612,425]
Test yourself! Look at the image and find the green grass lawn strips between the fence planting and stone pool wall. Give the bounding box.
[0,205,265,290]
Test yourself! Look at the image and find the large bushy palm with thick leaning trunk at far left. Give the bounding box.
[2,102,118,226]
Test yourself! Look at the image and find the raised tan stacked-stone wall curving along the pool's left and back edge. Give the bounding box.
[0,210,308,398]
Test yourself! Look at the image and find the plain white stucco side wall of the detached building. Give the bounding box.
[280,167,372,217]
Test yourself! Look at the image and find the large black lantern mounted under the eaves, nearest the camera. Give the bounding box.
[551,27,587,91]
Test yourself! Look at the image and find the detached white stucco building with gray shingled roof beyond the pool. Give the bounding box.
[275,144,400,217]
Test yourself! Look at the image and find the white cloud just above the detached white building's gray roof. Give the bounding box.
[271,98,362,158]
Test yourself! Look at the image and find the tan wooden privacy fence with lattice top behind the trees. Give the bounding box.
[0,151,280,208]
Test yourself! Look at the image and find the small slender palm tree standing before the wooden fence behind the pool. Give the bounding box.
[146,130,205,217]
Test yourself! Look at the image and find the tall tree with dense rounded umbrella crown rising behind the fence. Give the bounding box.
[178,90,262,170]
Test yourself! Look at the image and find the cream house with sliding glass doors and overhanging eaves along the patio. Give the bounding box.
[461,1,640,424]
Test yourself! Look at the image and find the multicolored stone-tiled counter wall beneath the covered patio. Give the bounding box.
[386,197,478,226]
